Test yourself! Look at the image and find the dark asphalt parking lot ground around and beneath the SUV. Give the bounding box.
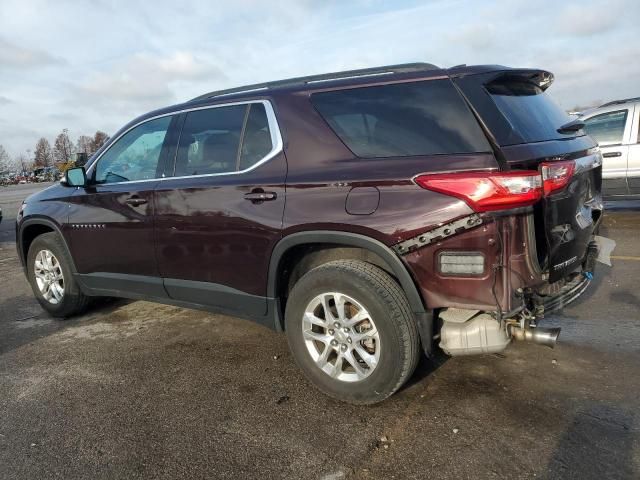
[0,185,640,480]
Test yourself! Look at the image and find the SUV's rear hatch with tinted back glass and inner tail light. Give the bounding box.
[452,69,602,283]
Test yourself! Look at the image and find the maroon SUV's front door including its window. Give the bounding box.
[69,116,175,297]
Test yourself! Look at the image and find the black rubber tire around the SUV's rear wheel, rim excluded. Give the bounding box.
[285,260,420,405]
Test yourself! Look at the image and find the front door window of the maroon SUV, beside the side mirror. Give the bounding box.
[94,116,171,184]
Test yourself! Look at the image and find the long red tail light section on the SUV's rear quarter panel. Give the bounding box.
[415,170,543,212]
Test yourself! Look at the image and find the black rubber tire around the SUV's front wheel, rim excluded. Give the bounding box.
[27,232,89,318]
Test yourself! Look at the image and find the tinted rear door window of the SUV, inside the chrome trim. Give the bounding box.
[175,103,273,176]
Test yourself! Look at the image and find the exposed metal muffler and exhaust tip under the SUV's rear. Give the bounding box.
[440,308,560,356]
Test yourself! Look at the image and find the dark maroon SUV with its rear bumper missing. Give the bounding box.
[16,64,602,403]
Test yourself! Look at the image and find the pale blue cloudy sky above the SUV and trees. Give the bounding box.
[0,0,640,155]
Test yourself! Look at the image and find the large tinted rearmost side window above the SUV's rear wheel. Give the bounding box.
[311,80,491,157]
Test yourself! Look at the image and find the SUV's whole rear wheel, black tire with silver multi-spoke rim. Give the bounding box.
[285,260,420,404]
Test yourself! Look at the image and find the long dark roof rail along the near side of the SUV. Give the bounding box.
[189,63,438,102]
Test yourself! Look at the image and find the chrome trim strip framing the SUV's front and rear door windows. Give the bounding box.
[87,100,284,186]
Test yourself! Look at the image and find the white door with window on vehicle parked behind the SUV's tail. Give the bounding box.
[583,105,634,195]
